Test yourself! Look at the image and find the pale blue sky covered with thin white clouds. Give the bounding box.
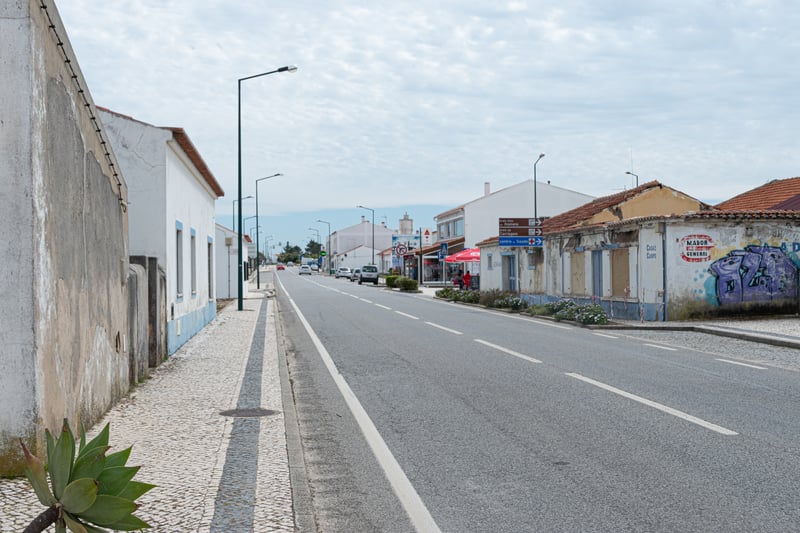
[57,0,800,249]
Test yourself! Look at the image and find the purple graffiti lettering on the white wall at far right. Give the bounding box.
[709,245,798,305]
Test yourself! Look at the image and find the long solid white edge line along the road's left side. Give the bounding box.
[281,276,441,533]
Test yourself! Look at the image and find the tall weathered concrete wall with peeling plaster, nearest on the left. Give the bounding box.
[0,0,129,474]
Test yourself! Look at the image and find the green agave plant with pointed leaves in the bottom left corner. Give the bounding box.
[21,419,155,533]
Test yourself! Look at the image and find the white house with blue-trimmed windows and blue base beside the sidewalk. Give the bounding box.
[100,109,224,354]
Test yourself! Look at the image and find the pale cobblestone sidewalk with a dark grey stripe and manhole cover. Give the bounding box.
[0,278,294,533]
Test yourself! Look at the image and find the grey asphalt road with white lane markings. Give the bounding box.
[276,269,800,532]
